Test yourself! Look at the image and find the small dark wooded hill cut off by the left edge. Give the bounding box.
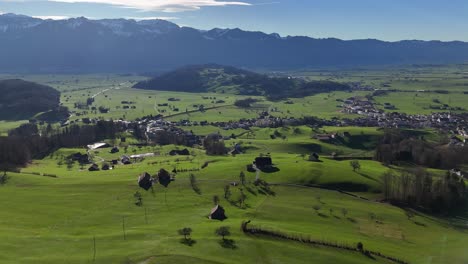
[0,79,60,120]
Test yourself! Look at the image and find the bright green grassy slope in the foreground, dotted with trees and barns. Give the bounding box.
[0,142,468,263]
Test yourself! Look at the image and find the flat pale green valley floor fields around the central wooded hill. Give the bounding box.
[0,65,468,133]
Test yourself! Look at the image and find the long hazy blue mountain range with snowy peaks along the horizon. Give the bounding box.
[0,14,468,72]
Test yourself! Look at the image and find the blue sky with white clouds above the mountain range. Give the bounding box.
[0,0,468,41]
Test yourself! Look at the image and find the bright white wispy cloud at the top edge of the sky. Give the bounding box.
[48,0,251,12]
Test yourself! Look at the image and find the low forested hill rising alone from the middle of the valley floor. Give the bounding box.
[134,64,350,99]
